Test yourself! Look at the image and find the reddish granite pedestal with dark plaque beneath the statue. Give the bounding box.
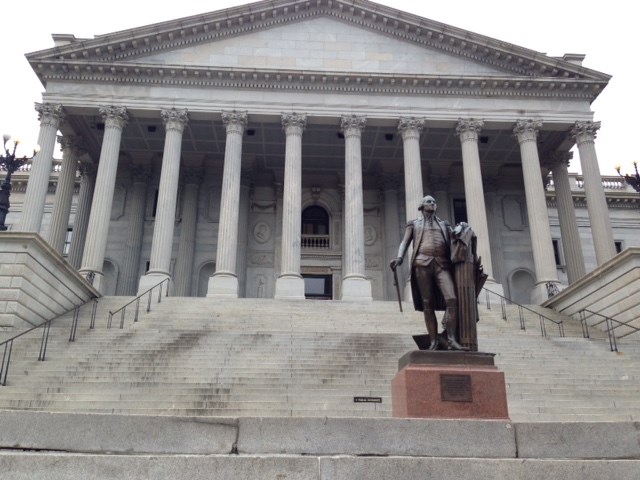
[391,351,509,420]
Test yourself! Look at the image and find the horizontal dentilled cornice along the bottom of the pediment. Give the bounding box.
[34,60,606,101]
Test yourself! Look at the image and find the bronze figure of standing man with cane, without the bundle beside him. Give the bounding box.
[390,195,467,350]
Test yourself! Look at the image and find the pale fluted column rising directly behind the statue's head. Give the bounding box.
[398,117,424,224]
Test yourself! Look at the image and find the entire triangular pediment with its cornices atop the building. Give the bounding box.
[27,0,610,99]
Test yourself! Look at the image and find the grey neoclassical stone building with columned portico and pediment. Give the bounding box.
[12,0,616,302]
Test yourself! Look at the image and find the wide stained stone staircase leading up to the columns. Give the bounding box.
[0,297,640,422]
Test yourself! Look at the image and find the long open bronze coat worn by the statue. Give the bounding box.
[398,215,451,312]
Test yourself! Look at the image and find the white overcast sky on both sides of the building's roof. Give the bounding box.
[0,0,640,175]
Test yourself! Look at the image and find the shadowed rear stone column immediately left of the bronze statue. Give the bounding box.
[379,175,404,300]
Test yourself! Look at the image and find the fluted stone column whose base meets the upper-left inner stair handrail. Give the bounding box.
[138,108,189,293]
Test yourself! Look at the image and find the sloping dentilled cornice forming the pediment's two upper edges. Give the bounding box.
[27,0,611,94]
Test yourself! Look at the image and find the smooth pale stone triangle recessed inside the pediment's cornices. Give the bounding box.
[131,16,516,77]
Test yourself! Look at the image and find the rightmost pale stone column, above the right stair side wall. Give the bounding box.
[571,118,616,265]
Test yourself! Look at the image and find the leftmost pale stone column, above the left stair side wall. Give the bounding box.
[16,103,66,233]
